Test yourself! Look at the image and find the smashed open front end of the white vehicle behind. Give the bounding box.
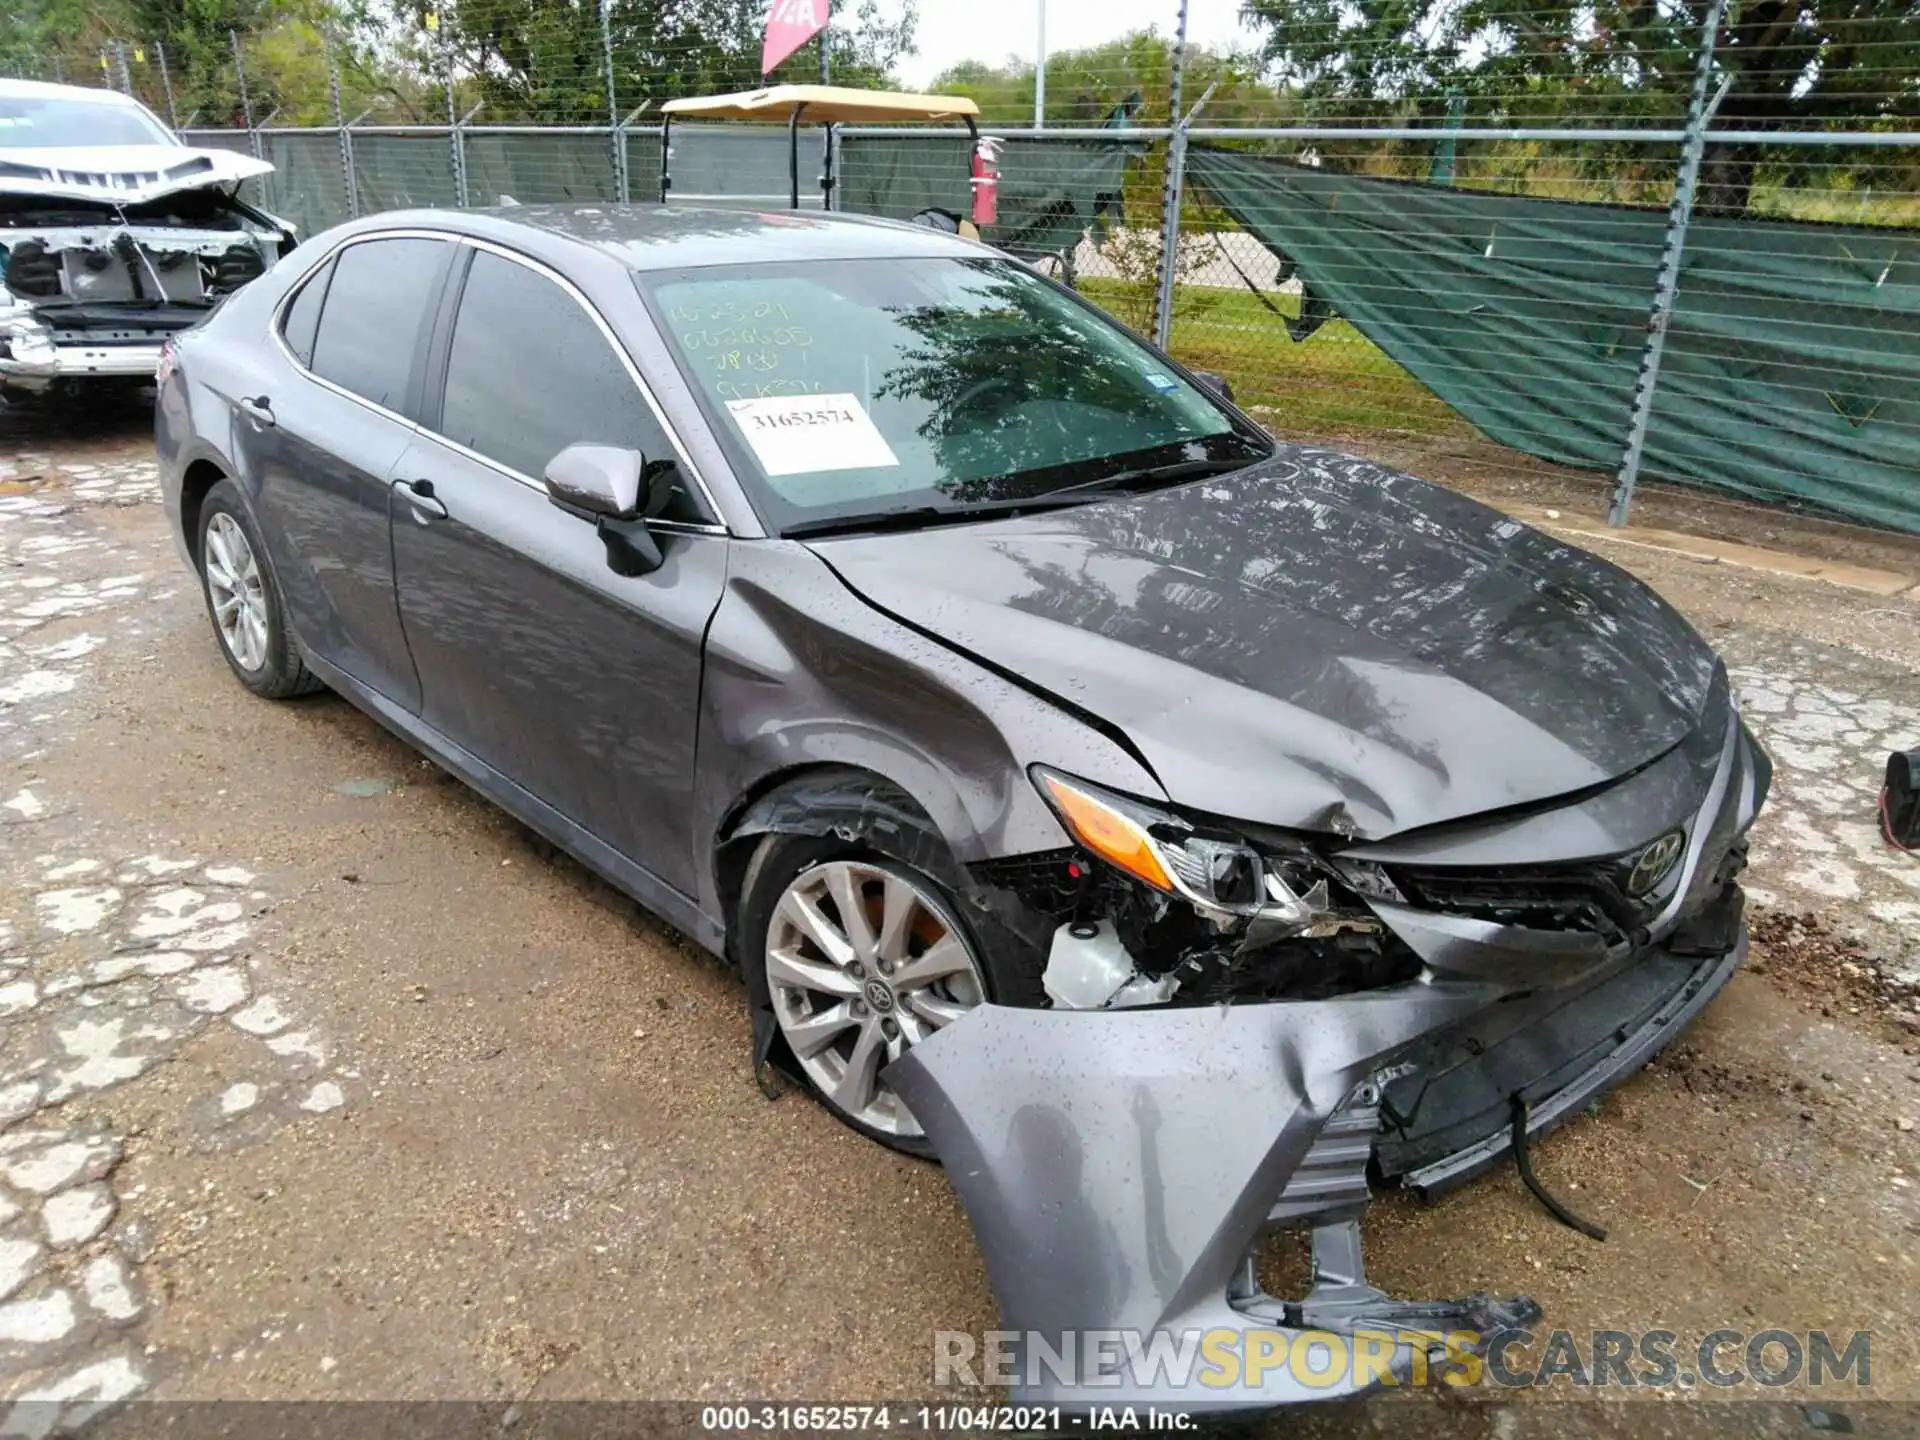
[0,173,294,390]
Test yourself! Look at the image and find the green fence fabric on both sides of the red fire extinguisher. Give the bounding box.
[837,134,1140,270]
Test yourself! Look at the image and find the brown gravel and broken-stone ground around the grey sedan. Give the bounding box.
[0,411,1920,1440]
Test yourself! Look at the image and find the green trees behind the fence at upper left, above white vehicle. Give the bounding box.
[0,0,916,127]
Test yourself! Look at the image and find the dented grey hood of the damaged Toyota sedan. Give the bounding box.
[814,447,1716,839]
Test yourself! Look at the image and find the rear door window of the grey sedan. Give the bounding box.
[309,240,447,411]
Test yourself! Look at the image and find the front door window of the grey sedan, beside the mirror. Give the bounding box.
[440,250,707,520]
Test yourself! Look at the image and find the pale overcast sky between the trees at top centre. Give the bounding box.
[883,0,1252,84]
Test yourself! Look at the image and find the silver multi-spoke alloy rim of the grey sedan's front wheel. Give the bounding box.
[766,860,987,1139]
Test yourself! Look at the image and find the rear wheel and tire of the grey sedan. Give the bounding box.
[194,480,323,701]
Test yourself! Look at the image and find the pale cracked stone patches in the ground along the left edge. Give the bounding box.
[0,459,348,1434]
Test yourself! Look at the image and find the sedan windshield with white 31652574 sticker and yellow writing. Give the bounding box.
[637,259,1271,530]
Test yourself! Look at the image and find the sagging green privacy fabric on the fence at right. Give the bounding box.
[1188,146,1920,532]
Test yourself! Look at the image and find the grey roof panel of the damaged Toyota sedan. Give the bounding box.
[328,205,985,271]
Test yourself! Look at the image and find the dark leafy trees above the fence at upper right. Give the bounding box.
[1242,0,1920,215]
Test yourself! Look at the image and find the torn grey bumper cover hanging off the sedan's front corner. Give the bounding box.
[885,981,1536,1409]
